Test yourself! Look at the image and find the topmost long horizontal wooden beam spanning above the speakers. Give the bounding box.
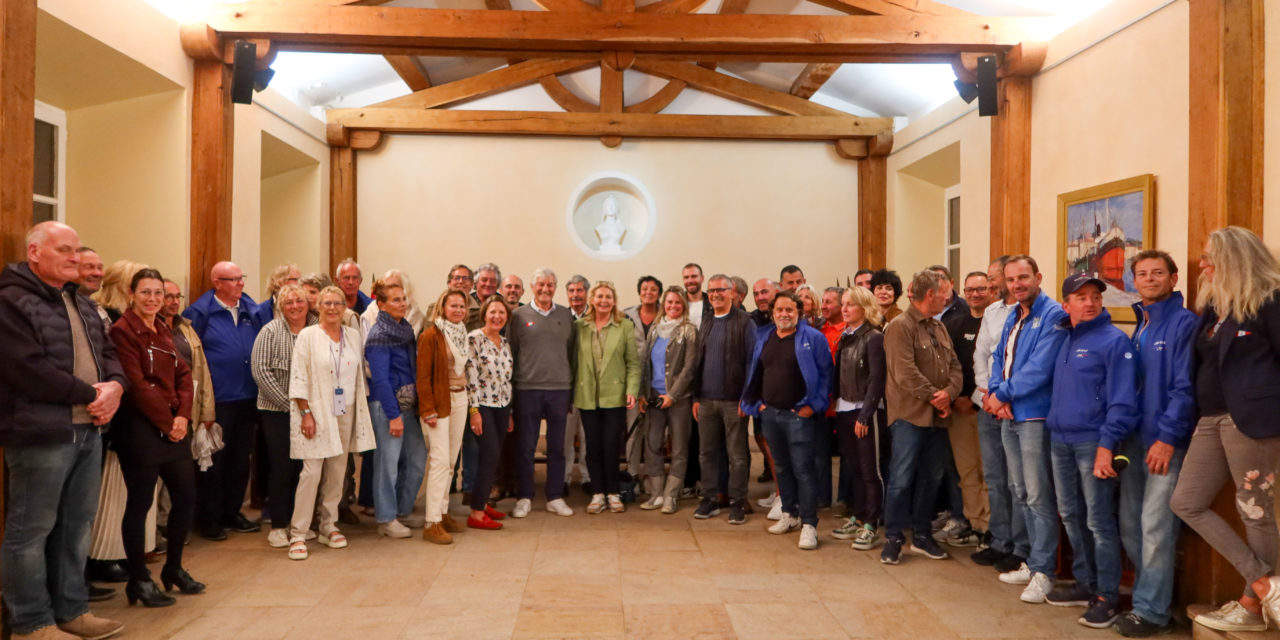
[191,5,1041,61]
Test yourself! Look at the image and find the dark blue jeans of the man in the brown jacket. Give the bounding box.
[884,420,950,540]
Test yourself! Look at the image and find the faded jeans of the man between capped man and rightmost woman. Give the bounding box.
[1120,435,1187,625]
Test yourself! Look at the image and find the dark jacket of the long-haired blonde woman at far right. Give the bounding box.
[1192,294,1280,438]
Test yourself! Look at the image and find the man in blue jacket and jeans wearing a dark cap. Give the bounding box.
[1046,273,1138,628]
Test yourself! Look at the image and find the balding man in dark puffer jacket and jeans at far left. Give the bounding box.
[0,221,127,639]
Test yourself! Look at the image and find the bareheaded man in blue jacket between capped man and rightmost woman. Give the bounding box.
[1116,250,1199,637]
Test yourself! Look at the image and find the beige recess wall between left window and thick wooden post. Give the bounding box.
[67,91,188,282]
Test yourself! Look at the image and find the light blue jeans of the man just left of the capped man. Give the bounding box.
[1000,420,1057,577]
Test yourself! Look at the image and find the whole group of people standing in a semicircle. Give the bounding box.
[0,223,1280,639]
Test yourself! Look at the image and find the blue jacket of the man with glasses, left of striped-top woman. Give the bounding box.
[182,289,262,402]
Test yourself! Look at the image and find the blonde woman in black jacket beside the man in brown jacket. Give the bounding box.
[831,287,887,550]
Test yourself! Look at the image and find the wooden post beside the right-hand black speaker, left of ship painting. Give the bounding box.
[991,76,1032,259]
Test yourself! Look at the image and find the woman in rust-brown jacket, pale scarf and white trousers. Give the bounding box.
[416,289,470,544]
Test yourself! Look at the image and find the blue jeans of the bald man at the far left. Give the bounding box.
[0,425,102,634]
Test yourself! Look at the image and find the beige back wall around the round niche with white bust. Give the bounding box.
[356,136,858,307]
